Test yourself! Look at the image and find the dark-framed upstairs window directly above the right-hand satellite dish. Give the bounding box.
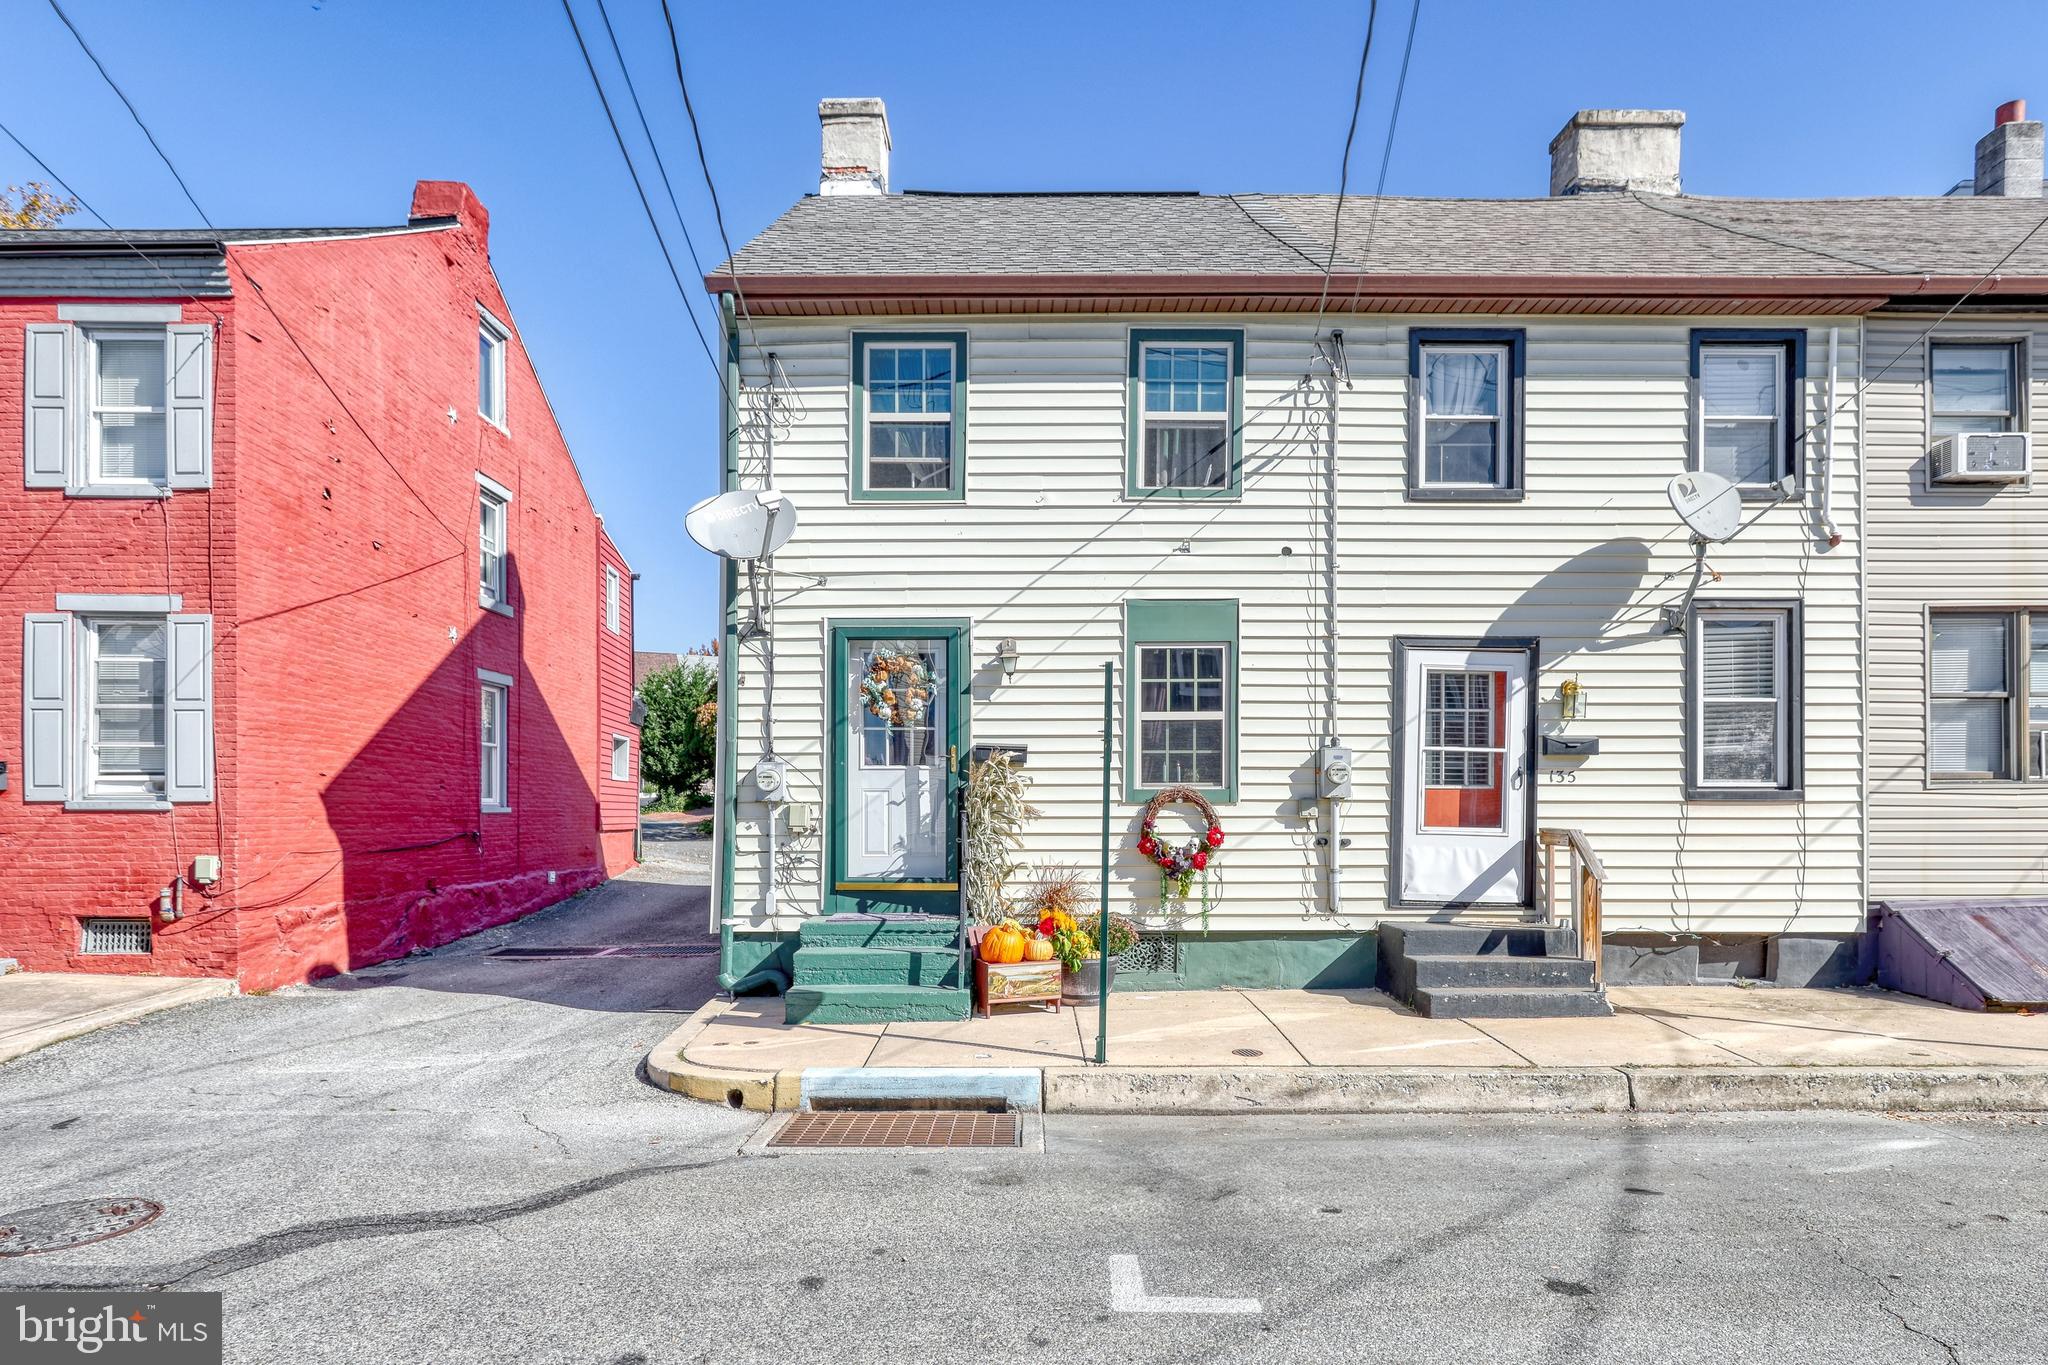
[1692,327,1806,497]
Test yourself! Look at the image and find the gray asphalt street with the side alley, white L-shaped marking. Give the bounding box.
[0,845,2048,1365]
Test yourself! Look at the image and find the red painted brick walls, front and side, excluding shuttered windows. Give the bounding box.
[0,184,631,988]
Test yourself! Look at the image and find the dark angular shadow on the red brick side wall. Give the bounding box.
[288,559,604,980]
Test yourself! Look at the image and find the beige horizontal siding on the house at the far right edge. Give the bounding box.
[1866,315,2048,900]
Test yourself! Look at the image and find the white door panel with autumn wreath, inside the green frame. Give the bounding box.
[842,636,952,882]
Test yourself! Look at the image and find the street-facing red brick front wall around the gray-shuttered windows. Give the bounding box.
[0,299,242,976]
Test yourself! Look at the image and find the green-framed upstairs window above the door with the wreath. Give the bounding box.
[852,332,967,501]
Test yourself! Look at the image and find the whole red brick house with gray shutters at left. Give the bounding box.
[0,180,639,988]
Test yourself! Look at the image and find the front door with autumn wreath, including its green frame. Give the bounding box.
[825,620,969,915]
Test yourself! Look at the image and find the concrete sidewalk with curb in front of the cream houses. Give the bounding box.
[647,986,2048,1113]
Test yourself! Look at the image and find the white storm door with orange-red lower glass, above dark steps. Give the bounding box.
[1397,649,1532,907]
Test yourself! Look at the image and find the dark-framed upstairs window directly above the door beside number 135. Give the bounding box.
[1409,327,1524,499]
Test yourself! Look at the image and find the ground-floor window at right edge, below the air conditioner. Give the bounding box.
[1927,608,2048,782]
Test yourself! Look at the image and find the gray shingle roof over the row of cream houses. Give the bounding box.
[721,194,2048,282]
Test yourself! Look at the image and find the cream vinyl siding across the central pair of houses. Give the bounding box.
[733,315,1862,933]
